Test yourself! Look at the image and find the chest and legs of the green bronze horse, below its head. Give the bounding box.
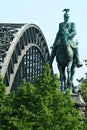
[55,42,75,91]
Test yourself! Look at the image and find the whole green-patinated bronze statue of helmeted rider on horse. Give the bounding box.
[50,9,82,91]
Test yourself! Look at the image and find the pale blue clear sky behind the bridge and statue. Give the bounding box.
[0,0,87,84]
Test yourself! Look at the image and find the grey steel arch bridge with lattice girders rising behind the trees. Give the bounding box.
[0,23,50,93]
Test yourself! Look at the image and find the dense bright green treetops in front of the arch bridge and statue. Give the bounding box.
[0,63,82,130]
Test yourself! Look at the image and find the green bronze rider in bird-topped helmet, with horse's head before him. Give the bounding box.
[50,9,82,67]
